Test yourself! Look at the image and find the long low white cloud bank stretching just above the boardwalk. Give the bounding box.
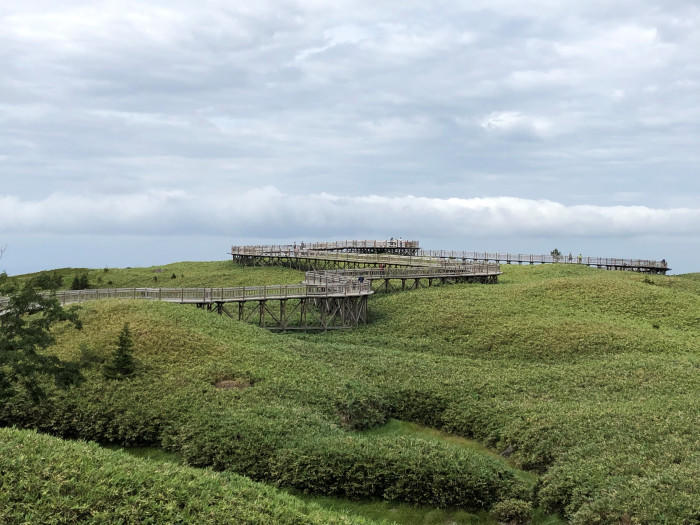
[0,186,700,238]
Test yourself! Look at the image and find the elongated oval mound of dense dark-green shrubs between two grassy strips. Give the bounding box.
[270,437,528,509]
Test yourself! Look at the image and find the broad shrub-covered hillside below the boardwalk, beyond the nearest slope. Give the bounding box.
[0,265,700,524]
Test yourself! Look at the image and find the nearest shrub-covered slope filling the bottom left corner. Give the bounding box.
[0,428,370,525]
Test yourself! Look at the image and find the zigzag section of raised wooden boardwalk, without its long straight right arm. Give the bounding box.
[0,240,501,331]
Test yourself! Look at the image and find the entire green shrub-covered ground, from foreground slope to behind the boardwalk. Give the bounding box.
[0,262,700,524]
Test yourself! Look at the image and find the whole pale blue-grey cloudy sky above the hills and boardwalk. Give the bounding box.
[0,0,700,273]
